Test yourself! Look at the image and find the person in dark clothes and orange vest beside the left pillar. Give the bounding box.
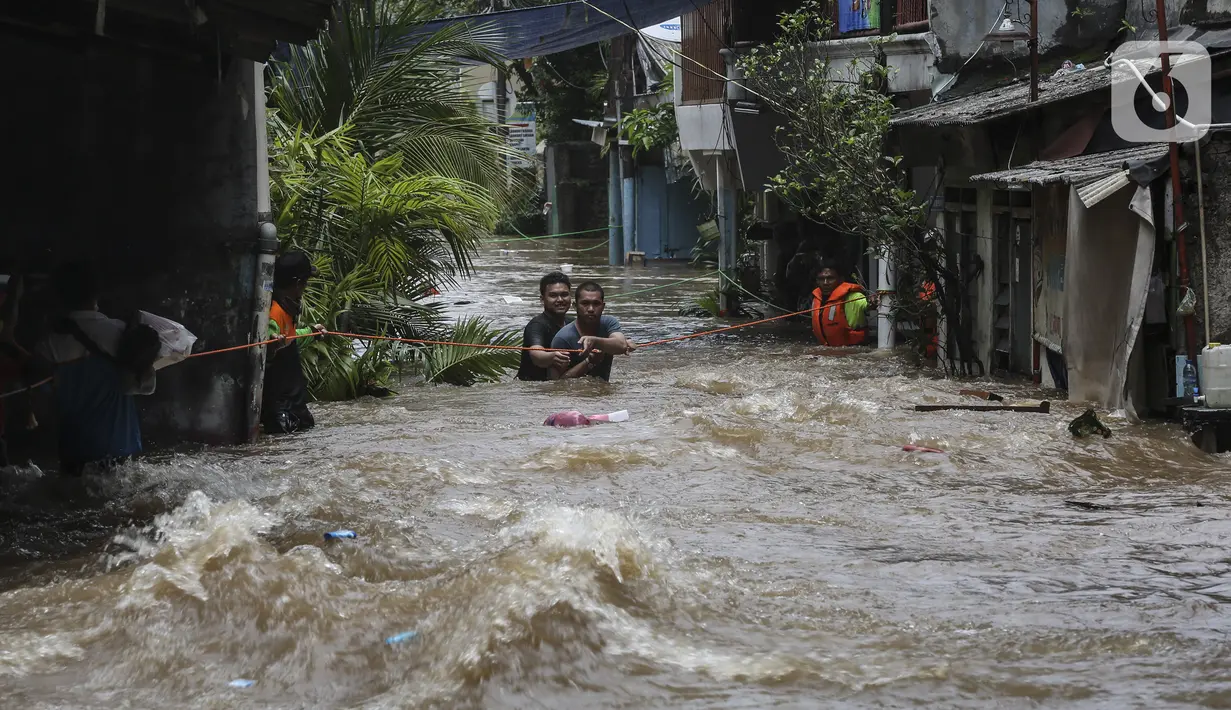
[261,251,325,434]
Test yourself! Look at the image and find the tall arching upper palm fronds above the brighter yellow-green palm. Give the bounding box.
[270,0,511,194]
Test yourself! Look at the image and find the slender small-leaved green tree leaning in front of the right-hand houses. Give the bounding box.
[741,0,976,372]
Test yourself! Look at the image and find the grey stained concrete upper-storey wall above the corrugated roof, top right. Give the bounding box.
[931,0,1137,74]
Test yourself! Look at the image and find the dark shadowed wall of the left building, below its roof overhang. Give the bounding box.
[0,34,263,443]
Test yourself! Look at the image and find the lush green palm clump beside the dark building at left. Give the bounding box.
[267,0,516,399]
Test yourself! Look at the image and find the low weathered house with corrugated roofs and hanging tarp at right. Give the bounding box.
[894,4,1231,415]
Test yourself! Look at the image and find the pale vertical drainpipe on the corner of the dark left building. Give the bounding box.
[244,62,278,443]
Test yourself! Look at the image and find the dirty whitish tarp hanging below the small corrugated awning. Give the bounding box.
[1064,185,1155,417]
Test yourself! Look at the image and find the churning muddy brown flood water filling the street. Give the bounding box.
[0,241,1231,709]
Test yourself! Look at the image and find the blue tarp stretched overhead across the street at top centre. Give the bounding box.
[409,0,713,59]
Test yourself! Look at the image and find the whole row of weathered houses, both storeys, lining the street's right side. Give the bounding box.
[677,0,1231,412]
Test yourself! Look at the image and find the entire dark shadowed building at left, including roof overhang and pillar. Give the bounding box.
[0,0,331,452]
